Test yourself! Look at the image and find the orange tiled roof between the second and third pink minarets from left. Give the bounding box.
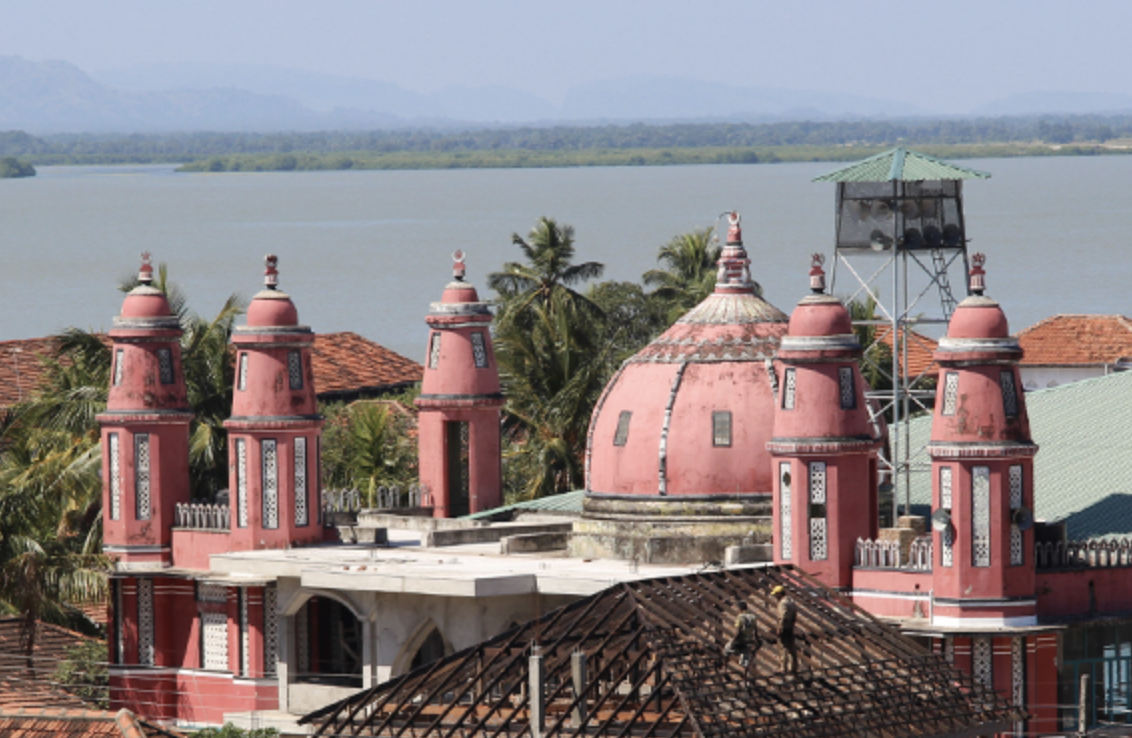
[312,331,425,398]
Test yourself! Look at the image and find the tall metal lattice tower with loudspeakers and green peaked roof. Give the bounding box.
[814,147,989,524]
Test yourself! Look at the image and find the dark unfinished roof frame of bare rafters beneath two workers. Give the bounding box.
[301,567,1022,738]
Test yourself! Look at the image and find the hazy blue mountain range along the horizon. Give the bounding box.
[0,55,1132,134]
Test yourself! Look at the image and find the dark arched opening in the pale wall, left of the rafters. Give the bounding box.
[294,597,363,688]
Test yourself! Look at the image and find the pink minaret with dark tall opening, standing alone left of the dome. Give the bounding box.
[415,251,504,517]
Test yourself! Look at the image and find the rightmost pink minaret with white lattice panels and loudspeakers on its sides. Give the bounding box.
[928,254,1038,627]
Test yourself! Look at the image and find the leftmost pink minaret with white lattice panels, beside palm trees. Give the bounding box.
[98,254,192,570]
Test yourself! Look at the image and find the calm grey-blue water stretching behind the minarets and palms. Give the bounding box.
[0,156,1132,358]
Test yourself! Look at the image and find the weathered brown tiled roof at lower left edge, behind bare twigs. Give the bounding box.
[0,616,96,710]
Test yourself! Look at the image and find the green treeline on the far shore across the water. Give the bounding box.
[0,115,1132,169]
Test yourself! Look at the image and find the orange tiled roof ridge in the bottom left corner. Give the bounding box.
[0,707,185,738]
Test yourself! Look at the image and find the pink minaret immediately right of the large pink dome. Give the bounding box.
[766,254,882,590]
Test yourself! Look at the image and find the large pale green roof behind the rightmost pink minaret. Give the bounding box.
[900,371,1132,540]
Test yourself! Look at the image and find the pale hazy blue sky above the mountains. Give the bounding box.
[0,0,1132,112]
